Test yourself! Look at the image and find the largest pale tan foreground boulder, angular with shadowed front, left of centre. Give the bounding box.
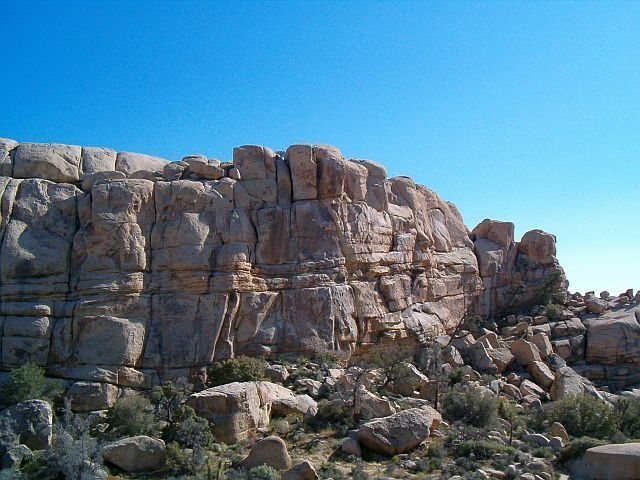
[187,382,317,444]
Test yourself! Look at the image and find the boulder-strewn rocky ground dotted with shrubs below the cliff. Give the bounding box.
[0,291,640,480]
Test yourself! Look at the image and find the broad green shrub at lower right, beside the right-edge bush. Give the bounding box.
[544,394,616,438]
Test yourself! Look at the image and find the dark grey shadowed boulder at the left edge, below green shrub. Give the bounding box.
[0,400,53,455]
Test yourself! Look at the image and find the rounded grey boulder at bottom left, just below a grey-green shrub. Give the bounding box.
[100,435,166,472]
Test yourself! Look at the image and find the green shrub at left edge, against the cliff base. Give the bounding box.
[0,363,62,405]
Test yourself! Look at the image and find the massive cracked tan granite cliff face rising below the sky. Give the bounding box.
[0,139,564,387]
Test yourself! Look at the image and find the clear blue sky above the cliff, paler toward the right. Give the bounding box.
[0,0,640,293]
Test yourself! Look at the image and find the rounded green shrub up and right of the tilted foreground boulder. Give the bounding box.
[442,385,497,428]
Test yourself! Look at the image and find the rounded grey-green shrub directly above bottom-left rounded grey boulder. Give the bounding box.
[107,395,157,437]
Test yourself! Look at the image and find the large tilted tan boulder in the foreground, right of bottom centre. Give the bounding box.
[358,407,442,456]
